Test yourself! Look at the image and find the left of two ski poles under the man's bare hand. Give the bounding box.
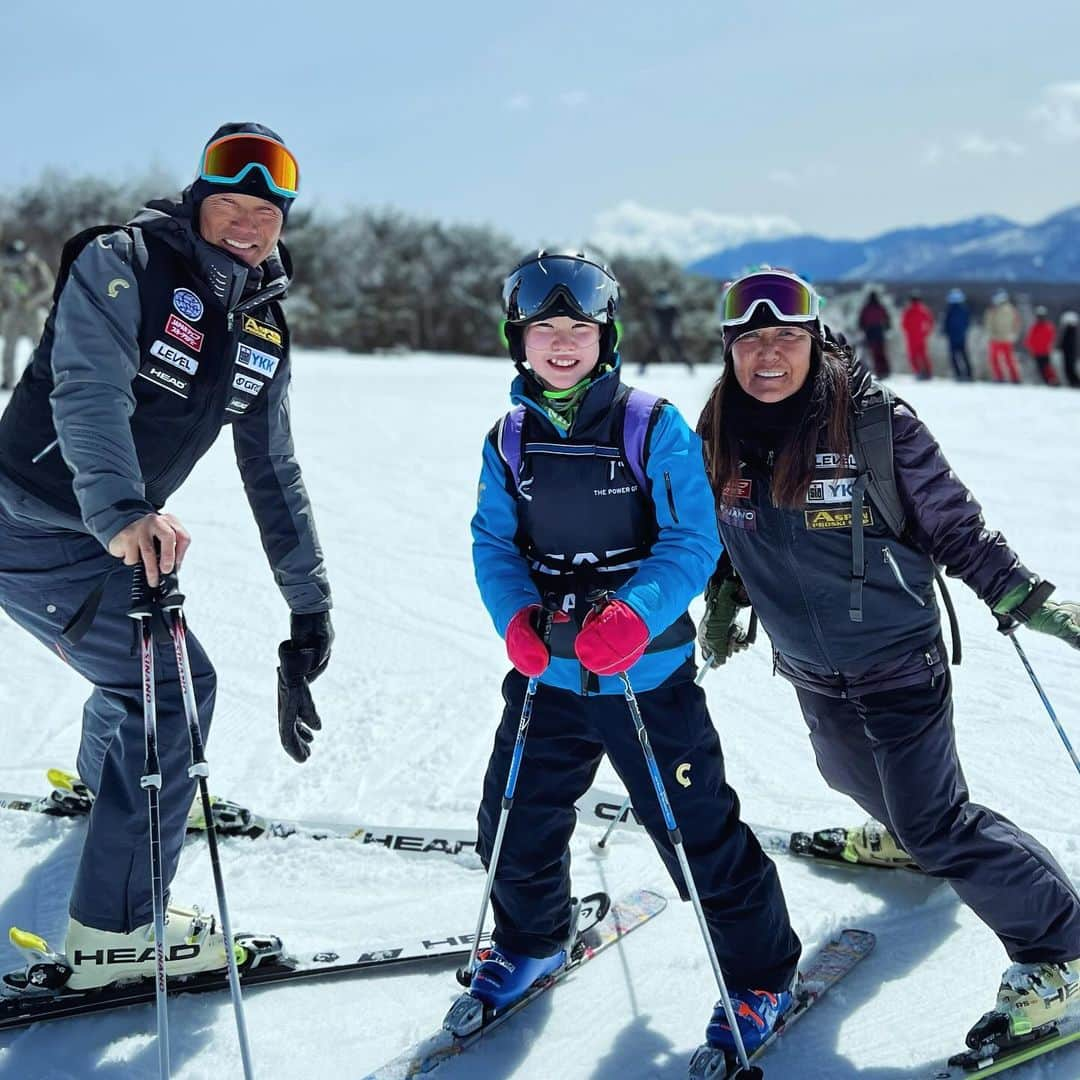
[127,563,170,1080]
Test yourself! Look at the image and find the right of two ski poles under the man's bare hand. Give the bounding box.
[160,573,255,1080]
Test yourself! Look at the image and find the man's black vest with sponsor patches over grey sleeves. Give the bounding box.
[0,226,288,517]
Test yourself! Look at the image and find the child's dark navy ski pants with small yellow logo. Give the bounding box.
[477,670,800,990]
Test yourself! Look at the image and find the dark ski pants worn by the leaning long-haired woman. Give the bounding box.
[797,671,1080,963]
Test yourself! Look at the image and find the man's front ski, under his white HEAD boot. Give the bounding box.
[0,893,609,1030]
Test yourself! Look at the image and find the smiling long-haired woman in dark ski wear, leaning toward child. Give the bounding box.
[699,270,1080,1054]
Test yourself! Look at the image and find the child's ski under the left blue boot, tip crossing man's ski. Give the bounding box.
[364,890,667,1080]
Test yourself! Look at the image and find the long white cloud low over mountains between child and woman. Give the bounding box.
[590,199,800,262]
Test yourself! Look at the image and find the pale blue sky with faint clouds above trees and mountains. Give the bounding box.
[0,0,1080,252]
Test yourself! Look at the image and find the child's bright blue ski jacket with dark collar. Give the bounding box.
[472,357,721,693]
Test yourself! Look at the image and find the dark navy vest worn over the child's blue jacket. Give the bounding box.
[492,372,694,659]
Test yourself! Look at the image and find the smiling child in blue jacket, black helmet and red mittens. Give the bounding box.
[471,252,800,1048]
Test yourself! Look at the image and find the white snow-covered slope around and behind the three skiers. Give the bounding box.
[0,352,1080,1080]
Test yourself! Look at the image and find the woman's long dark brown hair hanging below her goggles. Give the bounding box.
[698,337,852,510]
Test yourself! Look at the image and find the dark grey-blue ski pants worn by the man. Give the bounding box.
[0,505,216,931]
